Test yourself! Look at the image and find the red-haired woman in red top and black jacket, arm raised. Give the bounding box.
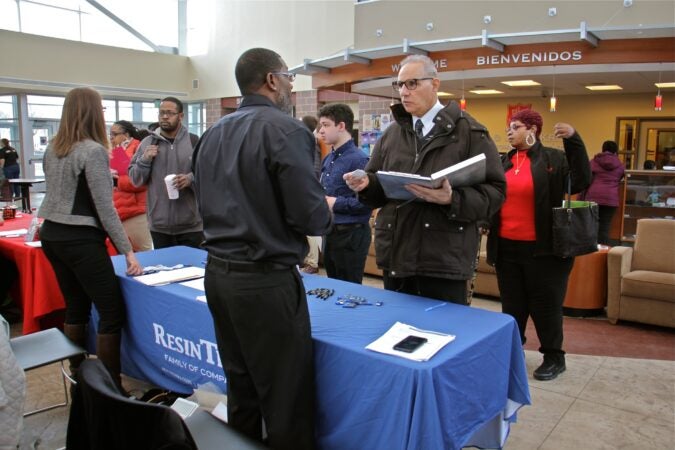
[487,109,591,381]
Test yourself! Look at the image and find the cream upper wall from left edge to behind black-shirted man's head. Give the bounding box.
[0,0,354,101]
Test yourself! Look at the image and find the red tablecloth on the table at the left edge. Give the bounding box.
[0,214,65,334]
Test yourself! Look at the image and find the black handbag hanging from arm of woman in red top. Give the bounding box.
[553,175,599,258]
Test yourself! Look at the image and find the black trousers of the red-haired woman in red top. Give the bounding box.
[495,239,574,354]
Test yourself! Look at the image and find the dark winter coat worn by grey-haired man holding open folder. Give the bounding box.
[359,101,506,280]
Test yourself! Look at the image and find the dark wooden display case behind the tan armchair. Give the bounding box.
[621,170,675,242]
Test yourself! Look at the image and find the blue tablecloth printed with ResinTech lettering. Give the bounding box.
[105,247,530,450]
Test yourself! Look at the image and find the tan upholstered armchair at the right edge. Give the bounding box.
[607,219,675,328]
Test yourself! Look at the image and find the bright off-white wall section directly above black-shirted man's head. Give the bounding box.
[185,0,354,99]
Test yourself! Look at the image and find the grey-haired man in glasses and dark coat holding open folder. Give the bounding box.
[344,55,505,304]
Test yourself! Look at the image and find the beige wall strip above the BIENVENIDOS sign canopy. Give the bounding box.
[354,0,675,49]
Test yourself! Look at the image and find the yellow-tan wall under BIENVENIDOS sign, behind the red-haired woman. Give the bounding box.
[467,92,675,156]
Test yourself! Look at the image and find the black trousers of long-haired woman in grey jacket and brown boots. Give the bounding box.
[42,239,126,334]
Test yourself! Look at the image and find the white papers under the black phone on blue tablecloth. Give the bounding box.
[366,322,455,361]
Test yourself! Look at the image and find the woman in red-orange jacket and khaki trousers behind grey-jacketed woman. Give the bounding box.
[110,120,152,252]
